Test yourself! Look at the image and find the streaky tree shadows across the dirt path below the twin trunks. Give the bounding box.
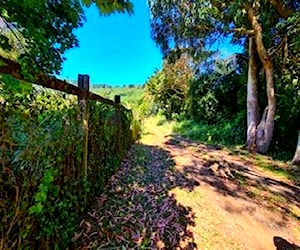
[165,136,300,222]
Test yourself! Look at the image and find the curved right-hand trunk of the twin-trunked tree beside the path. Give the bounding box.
[245,3,276,154]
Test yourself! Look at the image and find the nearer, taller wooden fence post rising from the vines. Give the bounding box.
[78,75,90,204]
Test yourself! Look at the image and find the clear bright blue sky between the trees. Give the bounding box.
[59,0,162,85]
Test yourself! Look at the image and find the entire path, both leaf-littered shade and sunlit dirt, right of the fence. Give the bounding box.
[73,119,300,249]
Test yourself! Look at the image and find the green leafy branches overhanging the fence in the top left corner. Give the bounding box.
[0,0,133,73]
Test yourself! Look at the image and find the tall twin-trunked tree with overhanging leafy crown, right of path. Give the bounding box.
[149,0,300,153]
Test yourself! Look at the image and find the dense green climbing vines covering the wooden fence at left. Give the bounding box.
[0,77,132,249]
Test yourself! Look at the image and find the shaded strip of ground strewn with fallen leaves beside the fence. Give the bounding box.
[73,144,198,249]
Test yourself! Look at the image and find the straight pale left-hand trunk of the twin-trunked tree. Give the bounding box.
[246,37,259,151]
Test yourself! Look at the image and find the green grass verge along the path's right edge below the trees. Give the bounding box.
[174,117,300,185]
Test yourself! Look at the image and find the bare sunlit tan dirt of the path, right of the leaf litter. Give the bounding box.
[144,118,300,249]
